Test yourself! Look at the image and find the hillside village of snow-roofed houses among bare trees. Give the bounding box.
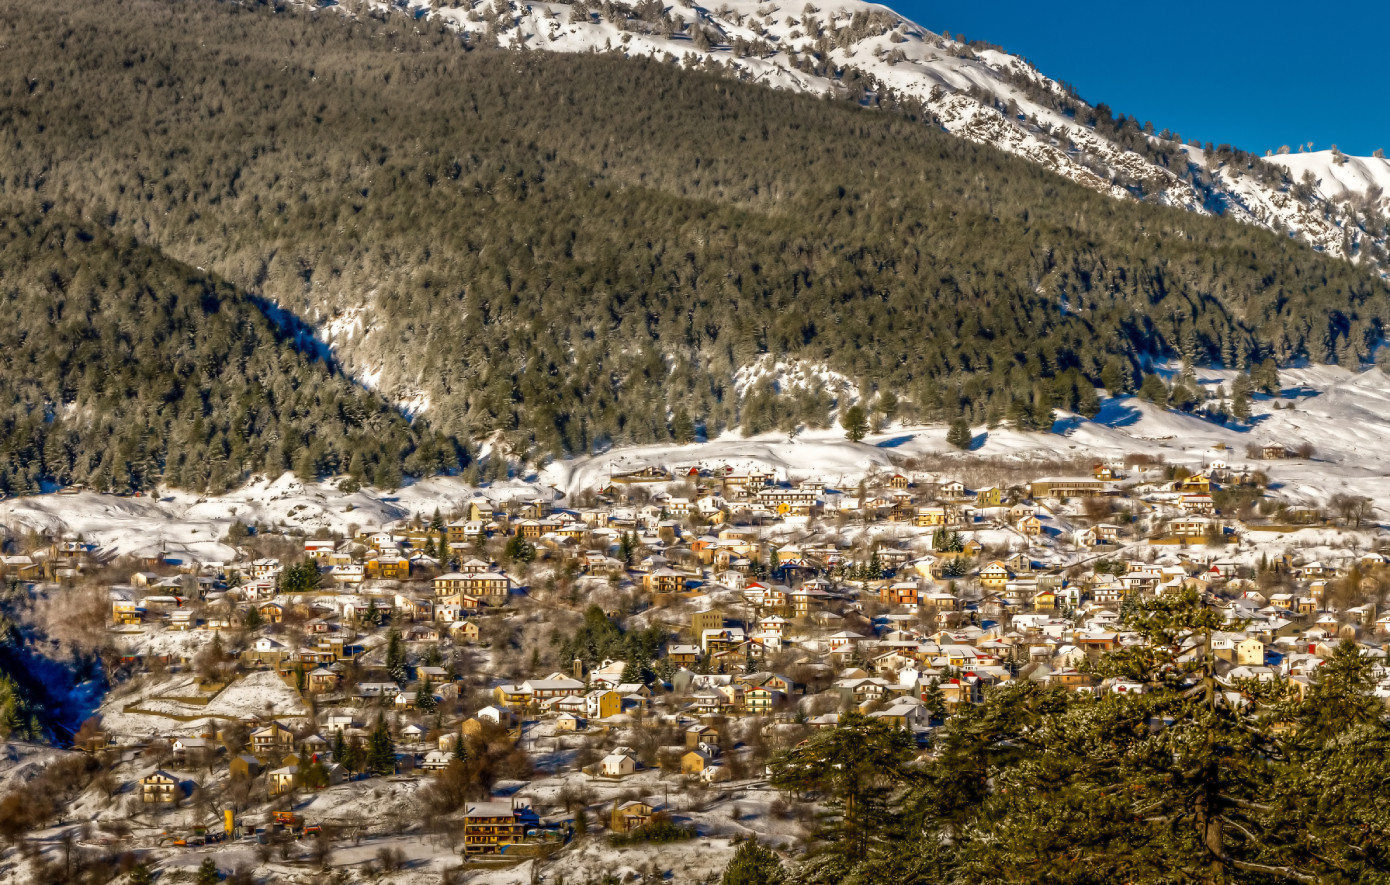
[0,443,1390,881]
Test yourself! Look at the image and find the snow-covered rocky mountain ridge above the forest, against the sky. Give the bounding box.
[330,0,1390,268]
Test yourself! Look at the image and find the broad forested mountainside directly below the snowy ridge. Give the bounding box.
[0,0,1390,482]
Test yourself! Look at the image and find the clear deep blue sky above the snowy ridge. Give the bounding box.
[911,0,1390,156]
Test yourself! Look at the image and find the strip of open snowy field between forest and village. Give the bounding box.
[0,367,1390,563]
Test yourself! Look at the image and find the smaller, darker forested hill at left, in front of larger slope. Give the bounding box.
[0,211,457,493]
